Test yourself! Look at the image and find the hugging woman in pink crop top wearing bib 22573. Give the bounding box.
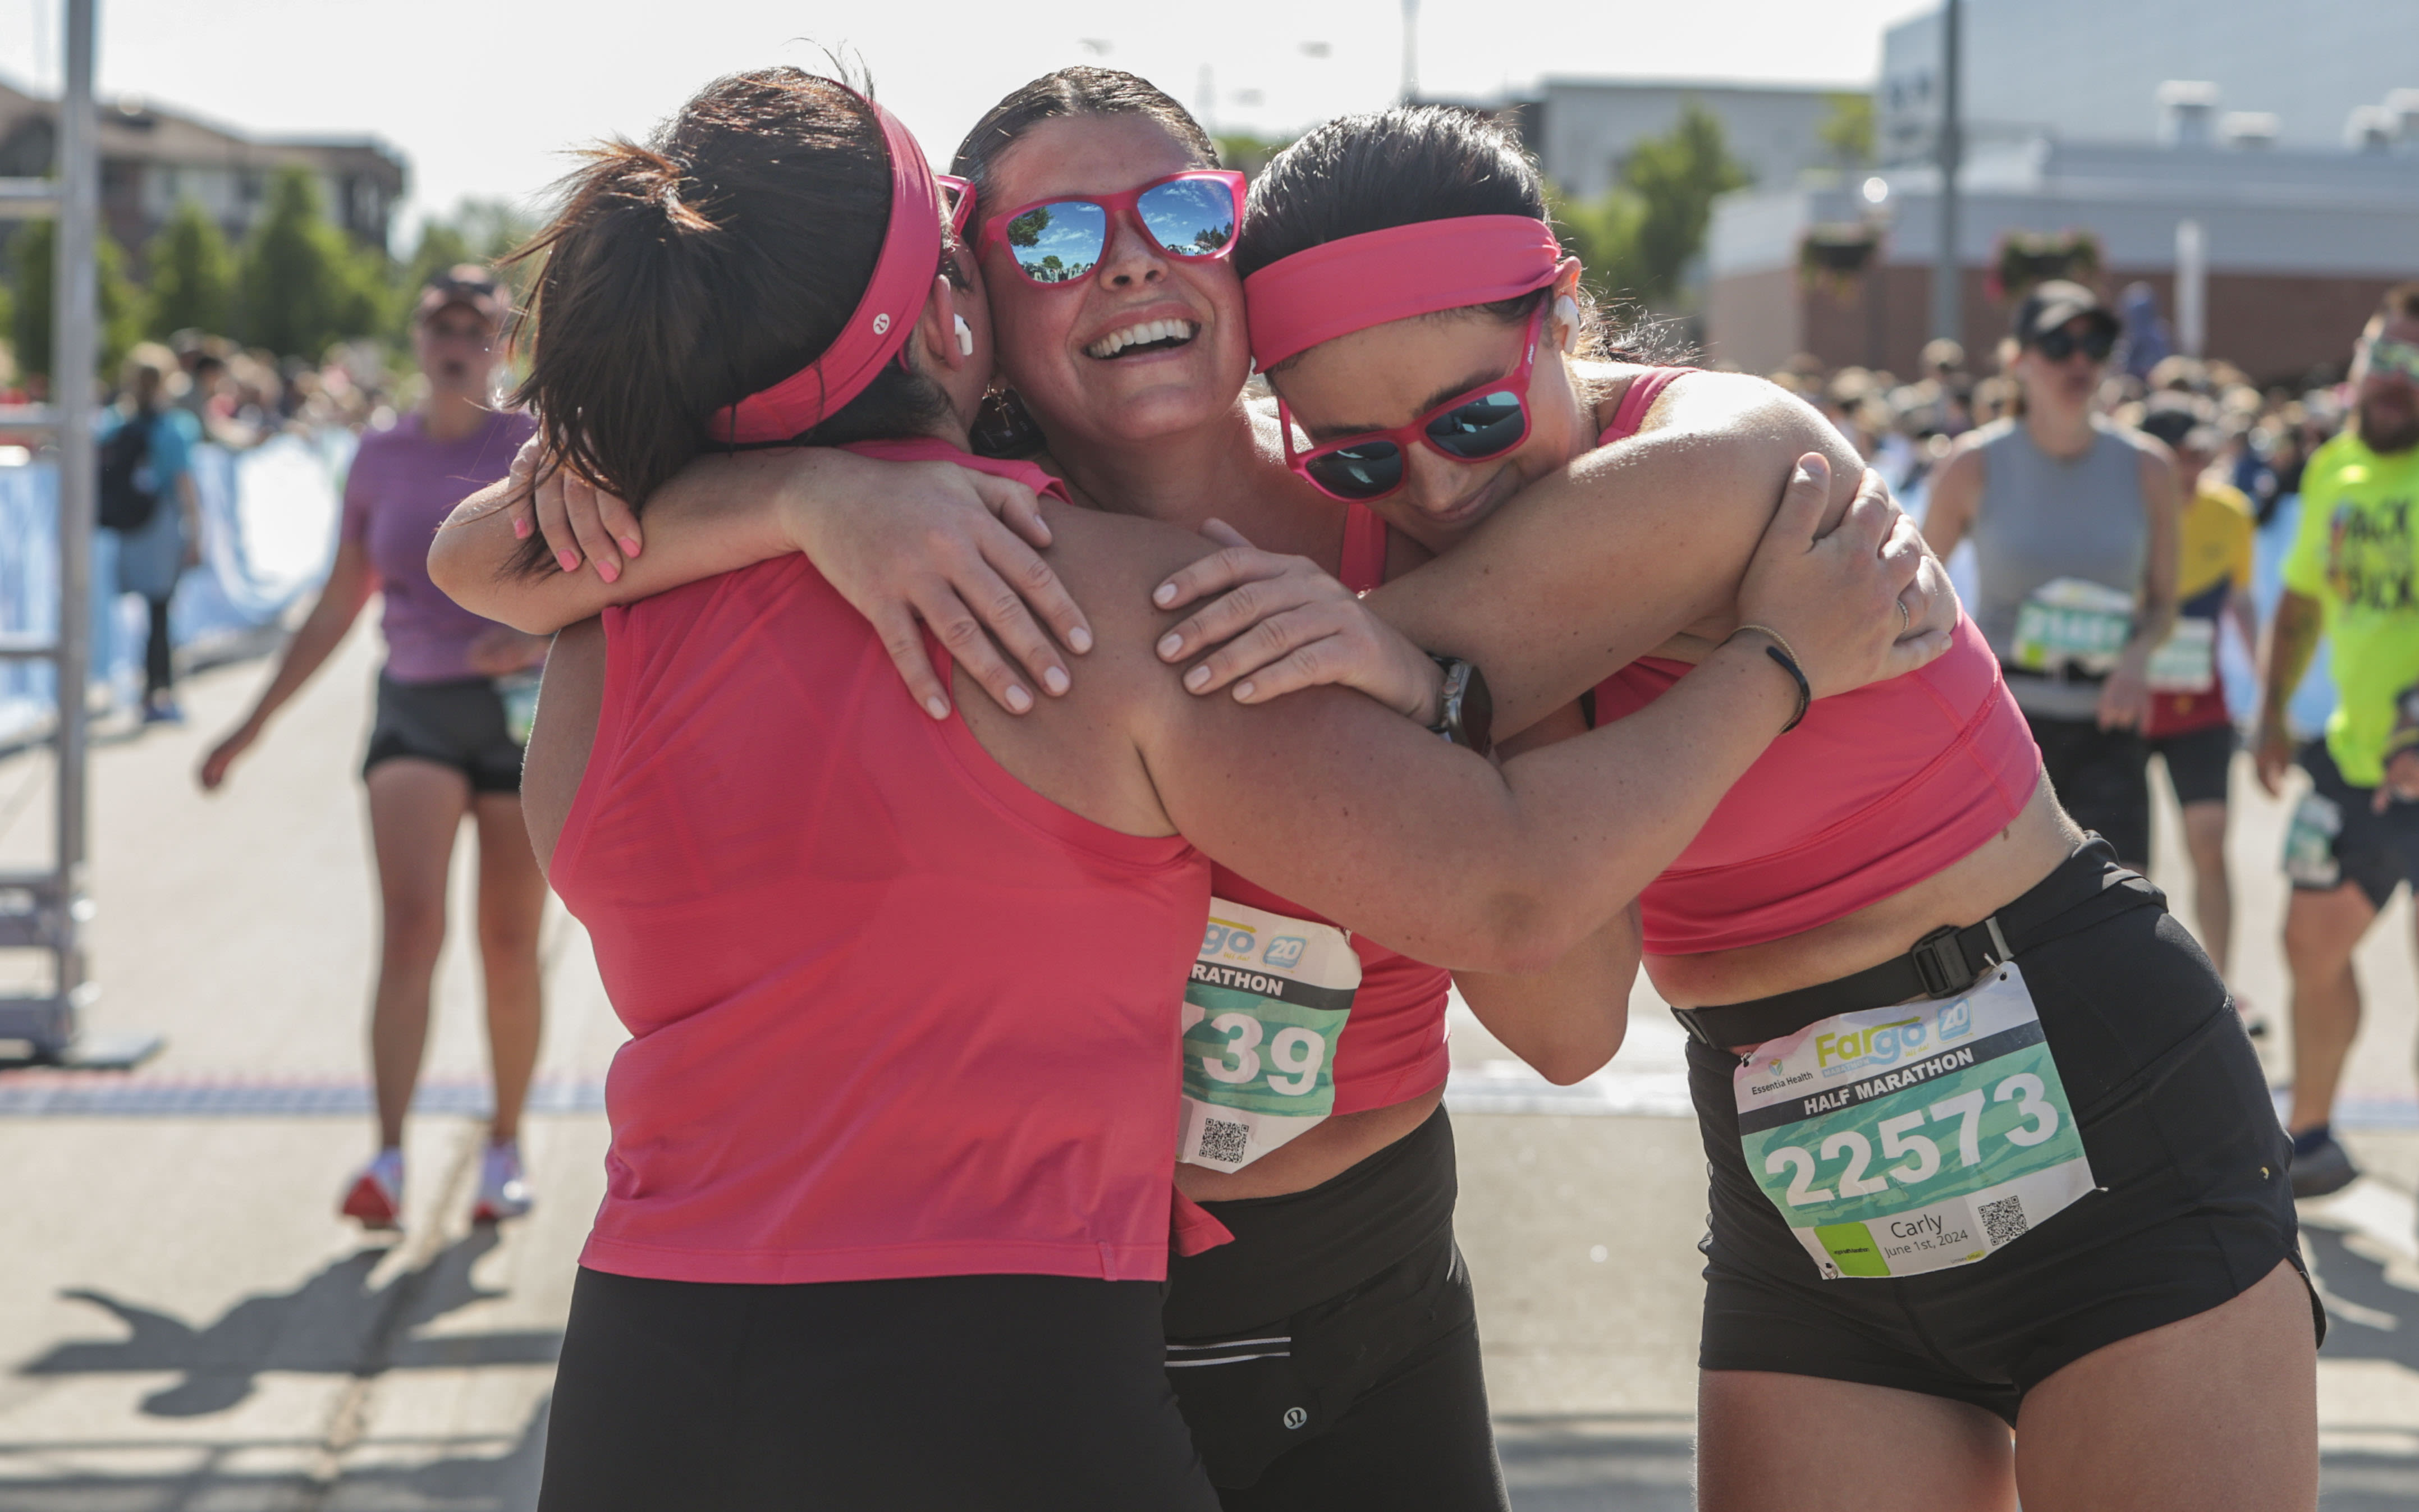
[1178,109,2325,1512]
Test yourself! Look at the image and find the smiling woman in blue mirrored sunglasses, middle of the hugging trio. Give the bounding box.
[436,70,1945,1512]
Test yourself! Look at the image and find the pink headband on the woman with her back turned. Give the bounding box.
[713,89,941,445]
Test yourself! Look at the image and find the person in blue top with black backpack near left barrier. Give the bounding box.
[97,341,201,723]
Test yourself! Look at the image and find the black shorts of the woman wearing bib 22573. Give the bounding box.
[1688,847,2325,1423]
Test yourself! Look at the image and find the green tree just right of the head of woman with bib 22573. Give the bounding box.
[1551,102,1751,310]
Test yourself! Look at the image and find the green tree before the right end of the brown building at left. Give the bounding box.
[240,167,392,358]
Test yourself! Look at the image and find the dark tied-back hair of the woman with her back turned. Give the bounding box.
[513,68,949,563]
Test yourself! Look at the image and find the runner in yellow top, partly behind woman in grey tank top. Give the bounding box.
[2141,404,2260,1033]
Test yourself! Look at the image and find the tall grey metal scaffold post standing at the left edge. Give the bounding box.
[0,0,159,1067]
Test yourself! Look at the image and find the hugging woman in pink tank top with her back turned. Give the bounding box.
[481,70,1926,1512]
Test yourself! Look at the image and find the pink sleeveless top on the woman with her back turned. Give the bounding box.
[552,443,1210,1282]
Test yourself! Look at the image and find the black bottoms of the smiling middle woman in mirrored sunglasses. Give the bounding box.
[1161,1108,1509,1512]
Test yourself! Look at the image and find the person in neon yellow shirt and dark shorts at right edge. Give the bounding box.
[2257,283,2419,1198]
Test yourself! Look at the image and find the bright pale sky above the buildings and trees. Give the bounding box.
[0,0,1935,242]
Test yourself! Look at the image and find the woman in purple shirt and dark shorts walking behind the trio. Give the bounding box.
[201,264,547,1229]
